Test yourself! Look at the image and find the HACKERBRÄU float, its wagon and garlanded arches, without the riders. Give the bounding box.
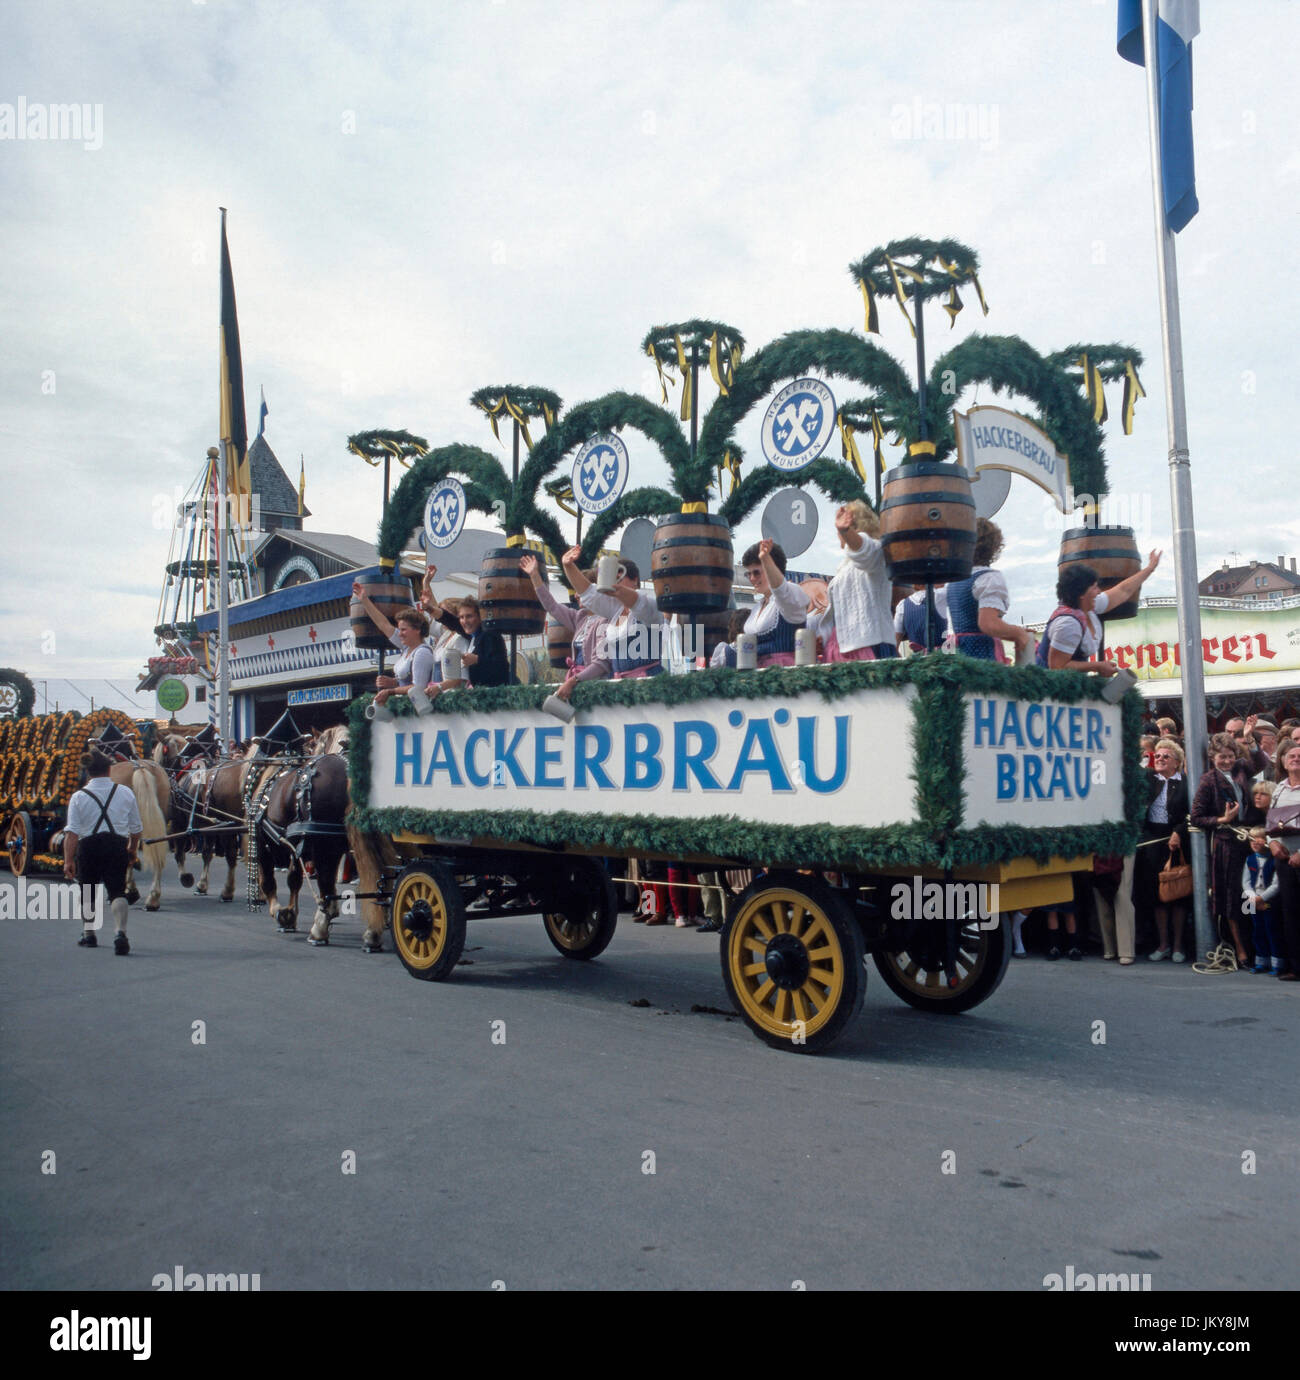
[349,240,1141,1052]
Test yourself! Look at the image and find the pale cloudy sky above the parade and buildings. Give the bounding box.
[0,0,1300,678]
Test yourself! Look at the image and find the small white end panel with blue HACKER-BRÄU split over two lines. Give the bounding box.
[963,694,1123,829]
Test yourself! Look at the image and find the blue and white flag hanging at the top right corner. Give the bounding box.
[1116,0,1201,233]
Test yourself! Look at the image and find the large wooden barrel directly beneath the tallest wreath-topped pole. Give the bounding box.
[880,460,976,585]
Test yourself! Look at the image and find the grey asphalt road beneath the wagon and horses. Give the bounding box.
[0,867,1300,1292]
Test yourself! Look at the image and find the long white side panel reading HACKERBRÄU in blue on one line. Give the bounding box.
[370,686,916,827]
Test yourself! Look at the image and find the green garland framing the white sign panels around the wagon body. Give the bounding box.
[349,653,1145,871]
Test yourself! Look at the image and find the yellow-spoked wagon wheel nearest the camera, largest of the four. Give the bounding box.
[722,872,867,1053]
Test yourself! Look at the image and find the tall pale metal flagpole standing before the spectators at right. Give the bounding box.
[1143,0,1217,954]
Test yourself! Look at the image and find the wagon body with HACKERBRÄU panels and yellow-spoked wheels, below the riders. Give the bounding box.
[349,653,1141,1052]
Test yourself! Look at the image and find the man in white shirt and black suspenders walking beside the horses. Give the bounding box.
[63,748,145,954]
